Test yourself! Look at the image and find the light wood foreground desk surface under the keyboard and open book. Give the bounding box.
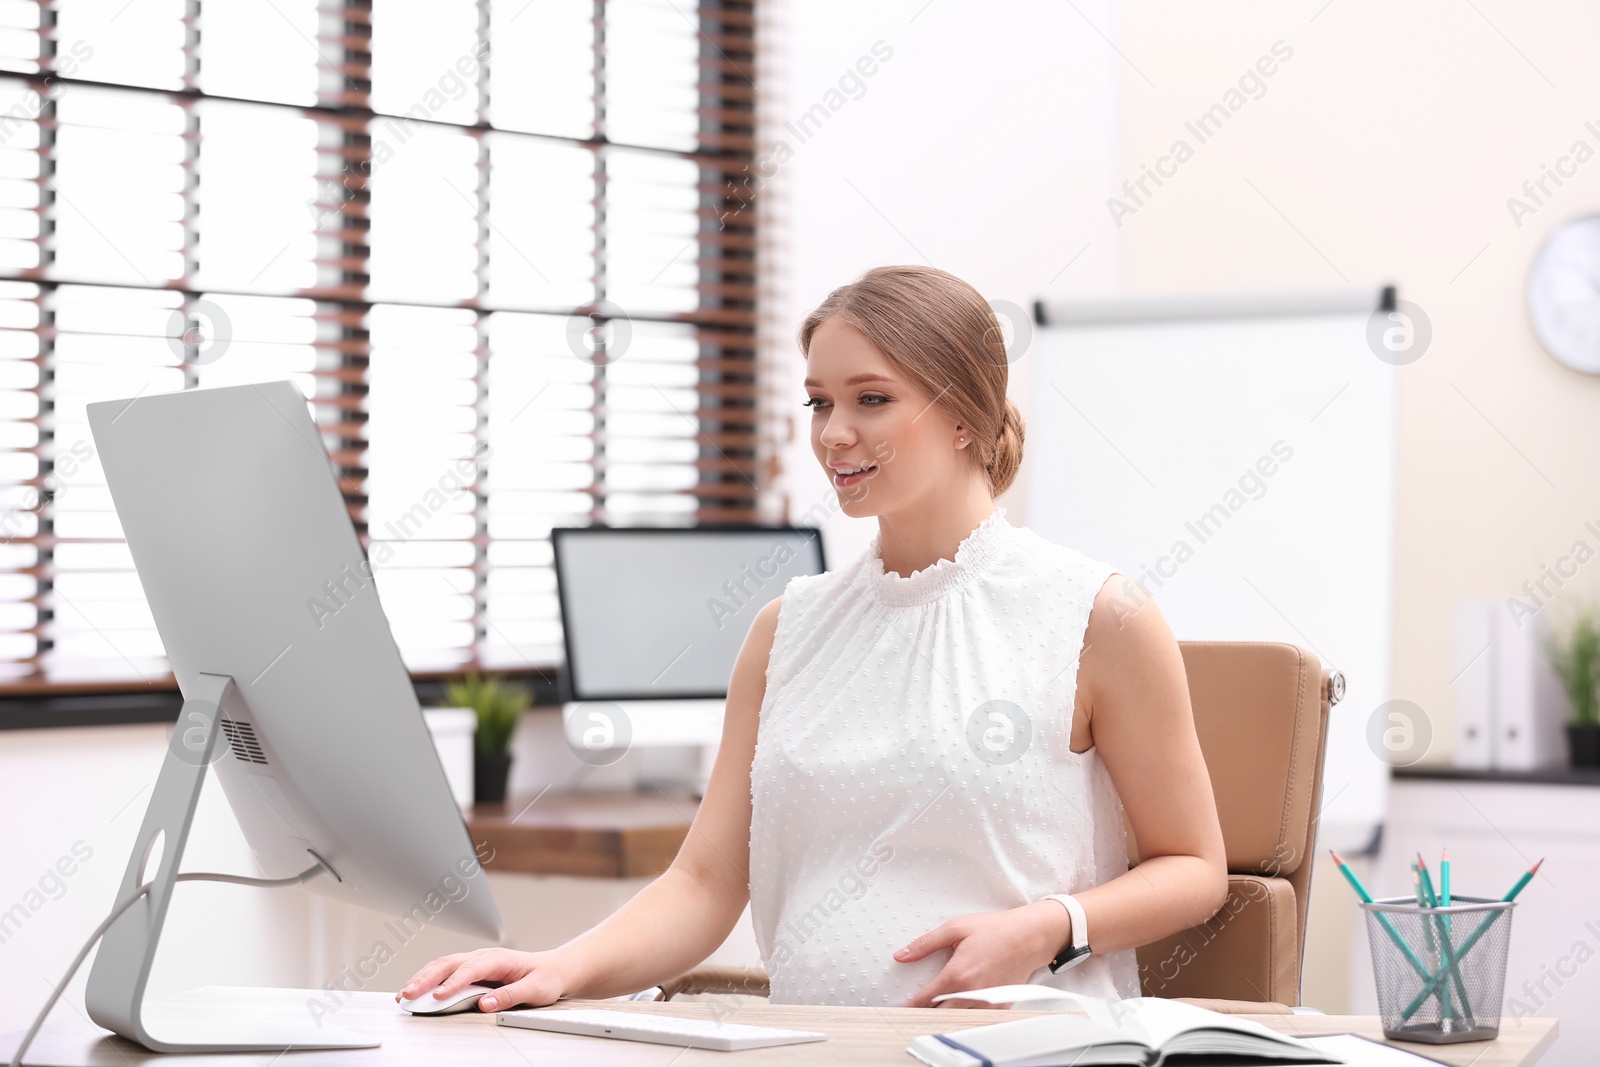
[0,985,1557,1067]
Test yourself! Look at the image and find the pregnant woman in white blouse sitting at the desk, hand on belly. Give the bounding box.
[400,266,1227,1011]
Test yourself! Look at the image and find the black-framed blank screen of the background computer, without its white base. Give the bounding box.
[550,526,826,701]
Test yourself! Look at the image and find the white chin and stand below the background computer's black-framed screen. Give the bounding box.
[562,697,725,797]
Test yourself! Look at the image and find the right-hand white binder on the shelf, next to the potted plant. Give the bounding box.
[1491,608,1570,771]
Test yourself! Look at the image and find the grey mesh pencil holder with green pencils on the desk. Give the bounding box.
[1362,896,1515,1045]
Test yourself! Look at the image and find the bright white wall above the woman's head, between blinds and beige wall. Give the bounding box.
[762,0,1120,550]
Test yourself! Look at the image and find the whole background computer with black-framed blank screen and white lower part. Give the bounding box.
[547,523,826,793]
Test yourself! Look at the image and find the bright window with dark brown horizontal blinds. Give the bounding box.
[0,0,765,694]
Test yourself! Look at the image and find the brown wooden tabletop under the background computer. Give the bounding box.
[467,790,699,878]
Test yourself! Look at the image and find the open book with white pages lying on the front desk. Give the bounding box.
[906,985,1344,1067]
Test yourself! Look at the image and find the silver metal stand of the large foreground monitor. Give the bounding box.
[85,673,379,1053]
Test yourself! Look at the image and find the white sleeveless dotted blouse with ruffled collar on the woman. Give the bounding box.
[750,507,1139,1006]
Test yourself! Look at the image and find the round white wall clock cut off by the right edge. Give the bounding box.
[1528,214,1600,374]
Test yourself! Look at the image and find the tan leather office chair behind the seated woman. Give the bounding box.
[658,641,1344,1014]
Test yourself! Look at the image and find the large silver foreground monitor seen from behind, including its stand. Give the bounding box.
[75,381,501,1053]
